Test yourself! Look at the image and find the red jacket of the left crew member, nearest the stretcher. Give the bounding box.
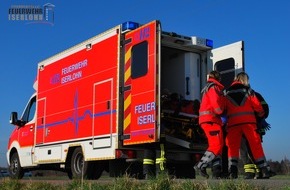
[199,78,224,125]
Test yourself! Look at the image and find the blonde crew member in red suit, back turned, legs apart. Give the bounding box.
[225,72,269,179]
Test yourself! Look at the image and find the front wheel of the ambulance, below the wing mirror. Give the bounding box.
[9,152,24,179]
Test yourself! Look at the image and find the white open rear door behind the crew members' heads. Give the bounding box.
[210,41,244,88]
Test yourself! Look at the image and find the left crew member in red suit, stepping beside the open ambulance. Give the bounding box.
[194,71,224,178]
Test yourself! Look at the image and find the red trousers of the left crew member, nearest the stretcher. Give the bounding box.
[201,123,224,156]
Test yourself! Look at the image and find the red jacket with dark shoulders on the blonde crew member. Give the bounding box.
[226,82,264,127]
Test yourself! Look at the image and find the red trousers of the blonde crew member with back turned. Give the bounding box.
[226,123,265,160]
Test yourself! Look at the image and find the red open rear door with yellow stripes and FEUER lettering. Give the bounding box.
[123,21,159,145]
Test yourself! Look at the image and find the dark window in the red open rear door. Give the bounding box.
[131,41,148,79]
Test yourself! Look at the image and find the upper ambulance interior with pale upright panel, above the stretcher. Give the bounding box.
[161,47,201,100]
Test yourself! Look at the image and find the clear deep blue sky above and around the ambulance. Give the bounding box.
[0,0,290,166]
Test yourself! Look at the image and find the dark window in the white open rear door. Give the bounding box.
[215,58,235,88]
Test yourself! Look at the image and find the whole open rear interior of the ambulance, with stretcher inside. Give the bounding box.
[160,32,208,145]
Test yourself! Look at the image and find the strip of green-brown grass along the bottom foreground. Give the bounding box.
[0,175,290,190]
